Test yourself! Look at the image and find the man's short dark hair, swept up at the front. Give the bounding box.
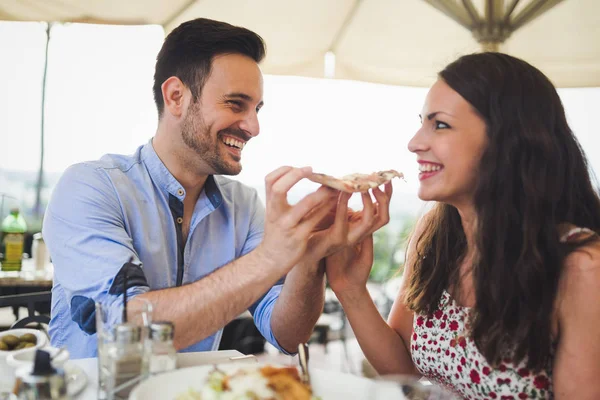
[153,18,266,118]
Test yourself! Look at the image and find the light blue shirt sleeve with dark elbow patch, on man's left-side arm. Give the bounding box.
[43,164,149,334]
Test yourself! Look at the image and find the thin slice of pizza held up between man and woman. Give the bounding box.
[308,169,404,193]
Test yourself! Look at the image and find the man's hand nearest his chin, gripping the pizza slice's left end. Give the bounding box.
[257,167,337,274]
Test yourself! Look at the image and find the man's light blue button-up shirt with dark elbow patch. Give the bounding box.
[43,141,281,358]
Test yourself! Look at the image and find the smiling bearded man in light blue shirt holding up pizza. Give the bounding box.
[43,19,391,358]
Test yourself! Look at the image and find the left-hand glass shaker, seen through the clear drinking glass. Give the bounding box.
[106,322,148,399]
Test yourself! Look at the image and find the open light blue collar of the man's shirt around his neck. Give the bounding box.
[141,139,223,208]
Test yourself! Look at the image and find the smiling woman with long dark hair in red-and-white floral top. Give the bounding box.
[326,53,600,399]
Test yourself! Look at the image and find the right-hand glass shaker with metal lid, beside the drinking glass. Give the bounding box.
[150,322,177,375]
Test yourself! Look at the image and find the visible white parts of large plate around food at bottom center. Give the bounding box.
[129,363,372,400]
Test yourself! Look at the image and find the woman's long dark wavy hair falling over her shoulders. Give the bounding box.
[405,53,600,370]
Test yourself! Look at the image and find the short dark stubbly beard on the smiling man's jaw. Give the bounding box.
[181,102,243,175]
